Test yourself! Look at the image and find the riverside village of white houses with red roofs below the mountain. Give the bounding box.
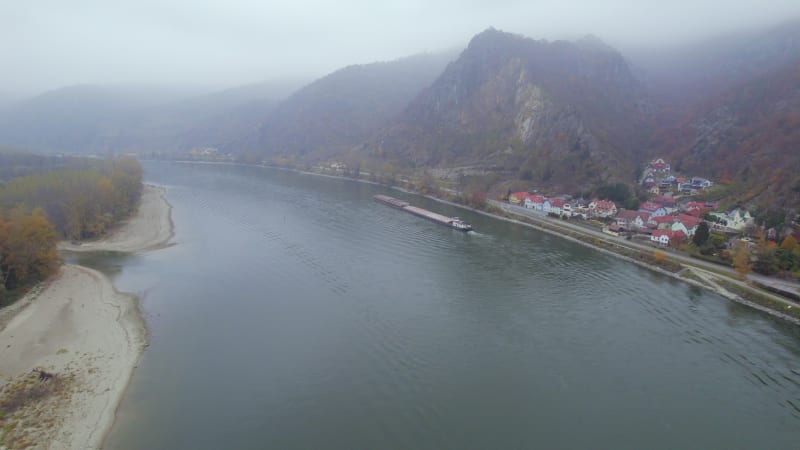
[507,158,754,248]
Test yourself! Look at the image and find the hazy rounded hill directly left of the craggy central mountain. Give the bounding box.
[239,53,453,158]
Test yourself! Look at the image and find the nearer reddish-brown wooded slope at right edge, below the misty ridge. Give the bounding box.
[649,32,800,214]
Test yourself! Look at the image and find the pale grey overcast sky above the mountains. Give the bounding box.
[0,0,800,95]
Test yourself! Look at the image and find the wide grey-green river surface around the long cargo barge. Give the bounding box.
[100,163,800,449]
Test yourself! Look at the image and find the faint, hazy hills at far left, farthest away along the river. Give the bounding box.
[0,82,298,153]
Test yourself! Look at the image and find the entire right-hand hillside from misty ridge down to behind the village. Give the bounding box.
[632,20,800,211]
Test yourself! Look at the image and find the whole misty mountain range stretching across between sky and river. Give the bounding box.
[0,21,800,208]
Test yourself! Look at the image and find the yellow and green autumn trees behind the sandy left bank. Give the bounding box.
[0,158,142,300]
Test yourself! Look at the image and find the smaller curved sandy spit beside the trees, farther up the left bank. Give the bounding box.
[58,185,173,253]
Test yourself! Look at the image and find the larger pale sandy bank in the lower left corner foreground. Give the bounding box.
[0,265,146,449]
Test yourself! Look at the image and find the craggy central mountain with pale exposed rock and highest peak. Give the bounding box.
[369,29,647,190]
